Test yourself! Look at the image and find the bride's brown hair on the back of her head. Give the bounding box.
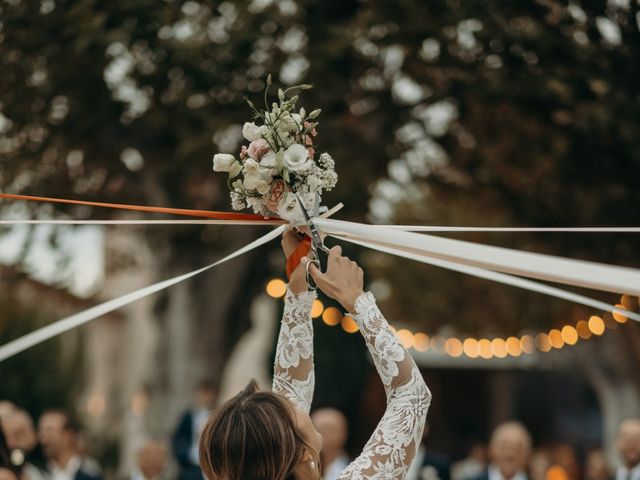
[200,381,306,480]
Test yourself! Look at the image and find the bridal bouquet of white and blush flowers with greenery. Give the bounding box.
[213,75,338,222]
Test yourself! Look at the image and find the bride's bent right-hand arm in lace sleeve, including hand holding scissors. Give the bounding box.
[309,247,431,480]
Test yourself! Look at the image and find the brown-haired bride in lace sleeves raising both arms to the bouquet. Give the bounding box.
[200,230,431,480]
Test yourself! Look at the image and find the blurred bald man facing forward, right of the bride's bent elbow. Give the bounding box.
[464,421,532,480]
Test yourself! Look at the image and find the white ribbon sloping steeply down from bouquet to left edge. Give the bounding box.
[0,225,286,362]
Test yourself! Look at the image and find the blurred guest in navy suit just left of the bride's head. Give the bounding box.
[171,380,217,480]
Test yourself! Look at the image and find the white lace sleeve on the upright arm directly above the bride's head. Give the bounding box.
[273,289,316,413]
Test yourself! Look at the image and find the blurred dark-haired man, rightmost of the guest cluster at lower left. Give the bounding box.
[38,410,102,480]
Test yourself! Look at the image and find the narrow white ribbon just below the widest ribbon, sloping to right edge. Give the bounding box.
[331,234,640,322]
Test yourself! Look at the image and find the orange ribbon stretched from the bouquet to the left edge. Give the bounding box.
[0,193,286,223]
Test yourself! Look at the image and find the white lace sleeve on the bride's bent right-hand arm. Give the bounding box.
[339,293,431,480]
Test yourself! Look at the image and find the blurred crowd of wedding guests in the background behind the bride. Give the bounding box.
[0,382,640,480]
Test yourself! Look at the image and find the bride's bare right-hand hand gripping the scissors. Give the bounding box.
[302,245,364,312]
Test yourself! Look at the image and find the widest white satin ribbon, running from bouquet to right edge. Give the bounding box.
[314,218,640,295]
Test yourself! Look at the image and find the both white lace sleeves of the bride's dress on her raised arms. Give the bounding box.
[273,291,431,480]
